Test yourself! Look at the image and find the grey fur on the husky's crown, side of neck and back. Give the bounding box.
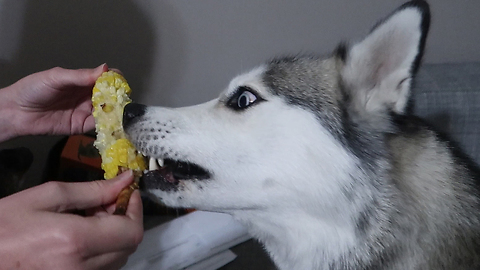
[258,1,480,269]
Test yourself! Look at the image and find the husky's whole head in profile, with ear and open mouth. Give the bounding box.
[123,1,429,214]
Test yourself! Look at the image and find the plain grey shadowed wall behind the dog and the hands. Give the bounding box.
[0,0,480,184]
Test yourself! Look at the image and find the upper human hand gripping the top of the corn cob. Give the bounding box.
[0,64,108,139]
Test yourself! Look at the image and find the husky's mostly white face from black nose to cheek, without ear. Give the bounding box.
[124,59,351,211]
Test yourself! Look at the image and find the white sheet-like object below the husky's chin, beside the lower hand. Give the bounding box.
[122,211,250,270]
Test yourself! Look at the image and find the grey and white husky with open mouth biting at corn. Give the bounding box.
[123,0,480,270]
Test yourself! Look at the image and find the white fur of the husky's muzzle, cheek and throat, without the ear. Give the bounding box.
[131,68,364,269]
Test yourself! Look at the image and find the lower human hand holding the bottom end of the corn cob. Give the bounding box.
[0,171,143,270]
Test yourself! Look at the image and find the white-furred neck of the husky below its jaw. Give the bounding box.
[230,163,393,270]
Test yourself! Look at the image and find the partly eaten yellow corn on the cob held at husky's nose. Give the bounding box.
[92,71,146,214]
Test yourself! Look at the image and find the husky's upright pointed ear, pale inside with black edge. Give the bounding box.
[337,0,430,118]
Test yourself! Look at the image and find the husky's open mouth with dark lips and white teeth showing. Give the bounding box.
[140,157,210,191]
